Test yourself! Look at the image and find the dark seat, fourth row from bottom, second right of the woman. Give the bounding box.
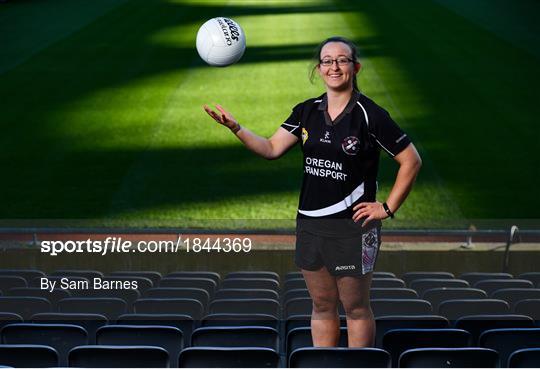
[439,299,510,321]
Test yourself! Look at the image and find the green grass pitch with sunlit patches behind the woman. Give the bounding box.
[0,0,540,227]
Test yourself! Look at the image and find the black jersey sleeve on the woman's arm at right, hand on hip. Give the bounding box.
[369,108,411,157]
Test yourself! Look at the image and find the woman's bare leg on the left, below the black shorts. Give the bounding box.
[302,267,339,347]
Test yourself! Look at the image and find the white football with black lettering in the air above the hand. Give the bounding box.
[197,17,246,67]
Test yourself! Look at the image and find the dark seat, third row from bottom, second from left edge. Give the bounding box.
[30,313,109,345]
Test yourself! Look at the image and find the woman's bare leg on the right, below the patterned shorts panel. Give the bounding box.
[337,273,375,347]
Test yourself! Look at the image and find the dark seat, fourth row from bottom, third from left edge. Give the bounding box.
[133,298,205,320]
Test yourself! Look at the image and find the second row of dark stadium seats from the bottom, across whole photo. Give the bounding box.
[0,324,540,367]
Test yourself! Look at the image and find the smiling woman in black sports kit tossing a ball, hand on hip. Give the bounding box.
[204,37,421,347]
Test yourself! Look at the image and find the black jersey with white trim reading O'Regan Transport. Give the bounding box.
[281,91,410,234]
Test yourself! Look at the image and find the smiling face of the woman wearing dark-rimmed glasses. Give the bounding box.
[317,42,360,91]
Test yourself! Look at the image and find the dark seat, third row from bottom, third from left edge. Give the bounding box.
[116,314,195,345]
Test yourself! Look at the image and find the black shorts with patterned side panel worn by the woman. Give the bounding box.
[294,218,381,276]
